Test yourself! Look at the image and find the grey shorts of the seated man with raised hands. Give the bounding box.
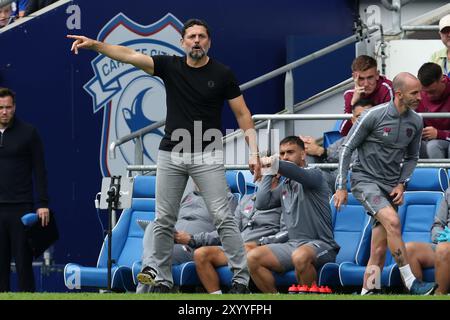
[267,240,339,272]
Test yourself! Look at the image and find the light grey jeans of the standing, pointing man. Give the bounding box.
[148,150,250,287]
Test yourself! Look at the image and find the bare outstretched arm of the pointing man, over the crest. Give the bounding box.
[67,35,154,75]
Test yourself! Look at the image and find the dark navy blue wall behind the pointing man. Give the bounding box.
[0,0,353,276]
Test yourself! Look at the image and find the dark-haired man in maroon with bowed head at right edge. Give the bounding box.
[416,62,450,159]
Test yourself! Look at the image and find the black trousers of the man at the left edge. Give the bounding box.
[0,204,35,292]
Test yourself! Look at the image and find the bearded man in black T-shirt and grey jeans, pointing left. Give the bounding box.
[68,19,260,293]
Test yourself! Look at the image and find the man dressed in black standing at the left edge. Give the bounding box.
[0,88,50,292]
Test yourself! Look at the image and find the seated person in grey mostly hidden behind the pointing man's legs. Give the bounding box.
[136,186,238,293]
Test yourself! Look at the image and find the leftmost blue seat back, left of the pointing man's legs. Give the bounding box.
[97,176,156,267]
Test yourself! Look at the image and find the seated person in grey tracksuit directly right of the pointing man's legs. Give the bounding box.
[181,175,287,294]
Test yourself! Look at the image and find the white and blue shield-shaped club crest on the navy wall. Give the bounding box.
[84,13,184,176]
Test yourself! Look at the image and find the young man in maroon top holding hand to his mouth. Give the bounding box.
[339,55,394,136]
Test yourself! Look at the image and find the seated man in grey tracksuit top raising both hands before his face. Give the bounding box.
[247,136,339,293]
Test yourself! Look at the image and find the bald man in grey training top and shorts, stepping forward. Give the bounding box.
[334,72,436,295]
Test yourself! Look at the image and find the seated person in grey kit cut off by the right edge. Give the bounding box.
[406,188,450,294]
